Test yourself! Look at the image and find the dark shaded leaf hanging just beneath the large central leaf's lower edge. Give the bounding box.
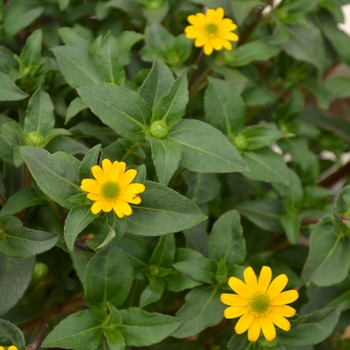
[182,170,221,205]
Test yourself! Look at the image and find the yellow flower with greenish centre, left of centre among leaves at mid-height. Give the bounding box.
[80,159,146,218]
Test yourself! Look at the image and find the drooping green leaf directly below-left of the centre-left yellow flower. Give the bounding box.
[64,205,96,250]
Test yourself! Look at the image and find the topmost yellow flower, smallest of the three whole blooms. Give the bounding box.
[185,7,238,55]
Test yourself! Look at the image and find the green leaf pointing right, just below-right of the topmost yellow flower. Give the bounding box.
[231,40,281,67]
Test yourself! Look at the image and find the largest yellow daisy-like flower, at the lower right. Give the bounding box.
[221,266,299,342]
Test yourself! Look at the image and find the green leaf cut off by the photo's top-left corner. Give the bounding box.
[0,0,44,40]
